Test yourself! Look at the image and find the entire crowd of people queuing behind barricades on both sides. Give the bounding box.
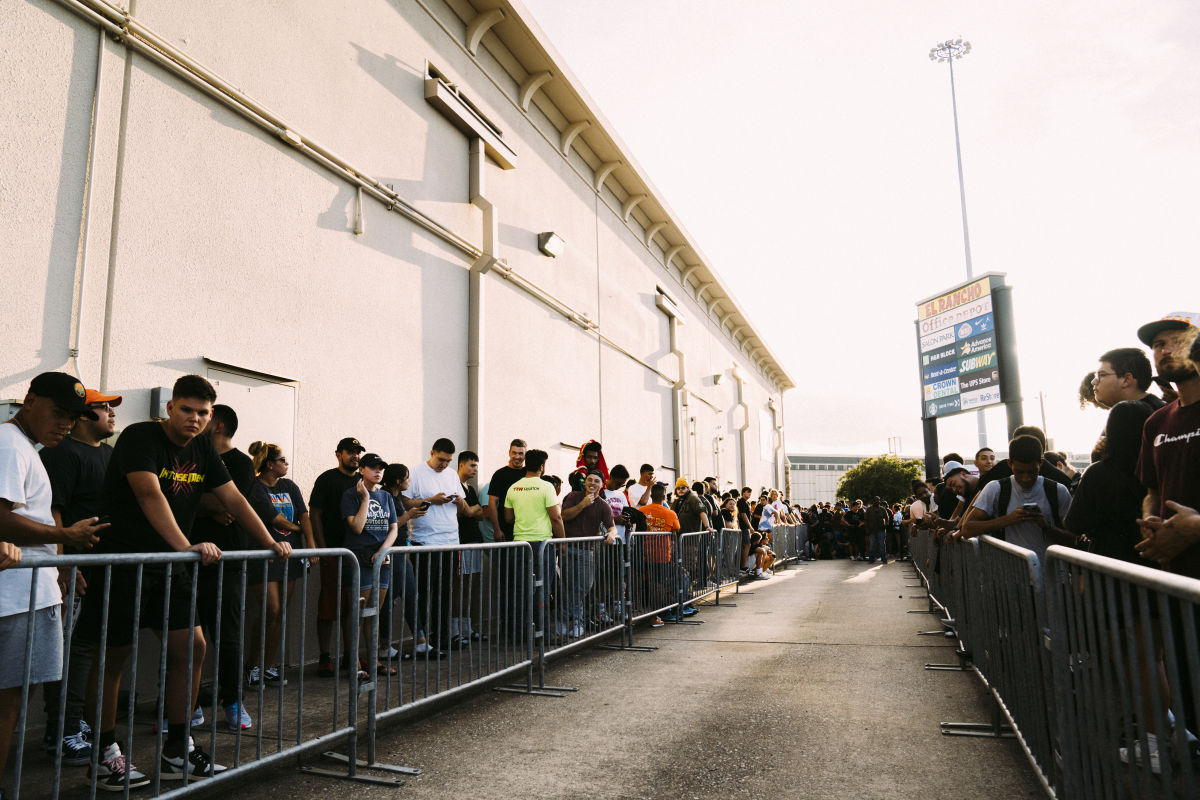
[0,314,1200,800]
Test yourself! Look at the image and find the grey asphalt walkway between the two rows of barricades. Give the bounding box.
[246,560,1043,800]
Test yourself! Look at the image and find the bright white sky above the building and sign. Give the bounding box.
[523,0,1200,455]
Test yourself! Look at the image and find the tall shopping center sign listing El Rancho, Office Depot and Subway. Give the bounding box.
[917,275,1007,420]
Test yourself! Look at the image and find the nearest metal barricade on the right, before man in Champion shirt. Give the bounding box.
[1045,547,1200,800]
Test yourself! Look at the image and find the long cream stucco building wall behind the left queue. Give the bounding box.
[0,0,782,494]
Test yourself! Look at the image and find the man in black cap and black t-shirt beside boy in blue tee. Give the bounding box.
[308,437,366,678]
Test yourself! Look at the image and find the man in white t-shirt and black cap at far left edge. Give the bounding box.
[0,372,107,796]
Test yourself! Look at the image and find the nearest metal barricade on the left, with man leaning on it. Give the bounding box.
[0,549,370,800]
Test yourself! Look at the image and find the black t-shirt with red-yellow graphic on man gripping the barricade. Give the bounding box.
[95,420,229,553]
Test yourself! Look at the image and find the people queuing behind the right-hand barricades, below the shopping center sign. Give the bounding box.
[907,312,1200,772]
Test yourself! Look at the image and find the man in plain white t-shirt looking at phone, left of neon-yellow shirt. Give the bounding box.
[402,438,468,650]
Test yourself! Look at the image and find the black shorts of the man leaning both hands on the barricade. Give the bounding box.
[74,564,200,646]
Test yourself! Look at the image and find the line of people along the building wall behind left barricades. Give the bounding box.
[0,373,800,798]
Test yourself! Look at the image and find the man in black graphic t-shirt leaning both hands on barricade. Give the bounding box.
[78,375,292,789]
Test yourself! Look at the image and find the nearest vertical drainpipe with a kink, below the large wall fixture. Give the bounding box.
[467,137,499,452]
